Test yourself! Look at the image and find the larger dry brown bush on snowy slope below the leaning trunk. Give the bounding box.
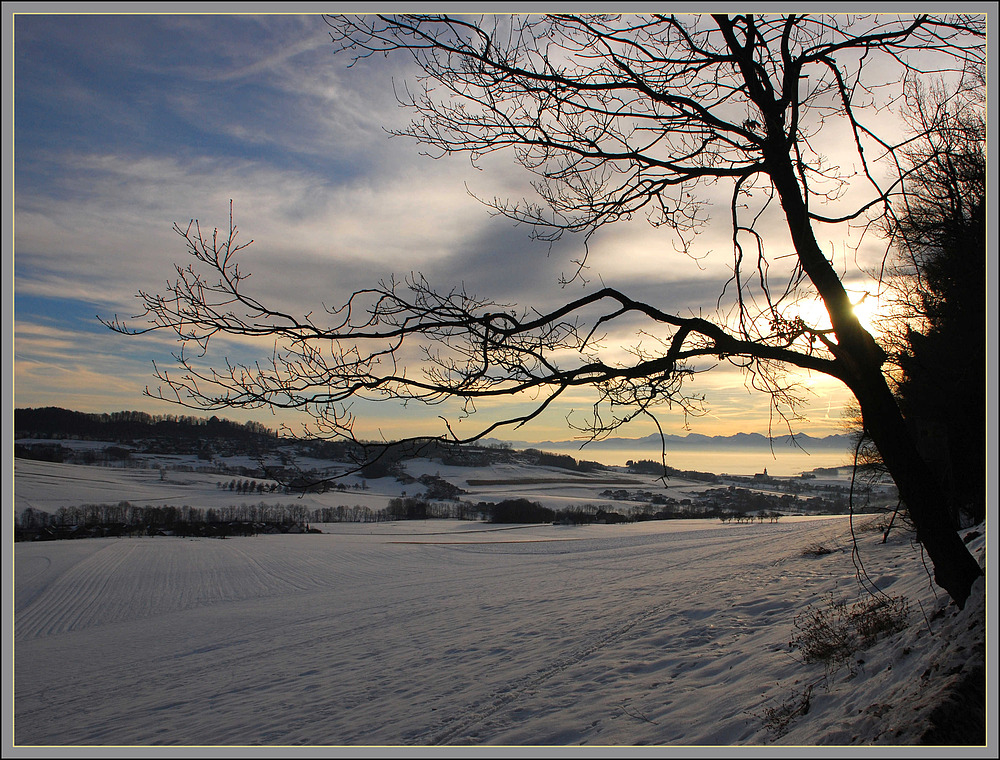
[789,596,910,669]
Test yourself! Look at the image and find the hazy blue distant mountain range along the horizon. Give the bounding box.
[492,433,851,451]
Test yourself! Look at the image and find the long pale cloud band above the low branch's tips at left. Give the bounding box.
[15,145,489,304]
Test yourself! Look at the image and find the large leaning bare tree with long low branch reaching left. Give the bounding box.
[103,15,985,605]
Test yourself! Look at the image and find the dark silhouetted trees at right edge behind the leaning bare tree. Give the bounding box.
[891,82,988,525]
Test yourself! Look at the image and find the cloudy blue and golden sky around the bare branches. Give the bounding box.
[5,4,992,441]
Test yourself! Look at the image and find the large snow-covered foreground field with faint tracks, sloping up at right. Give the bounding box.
[12,462,996,757]
